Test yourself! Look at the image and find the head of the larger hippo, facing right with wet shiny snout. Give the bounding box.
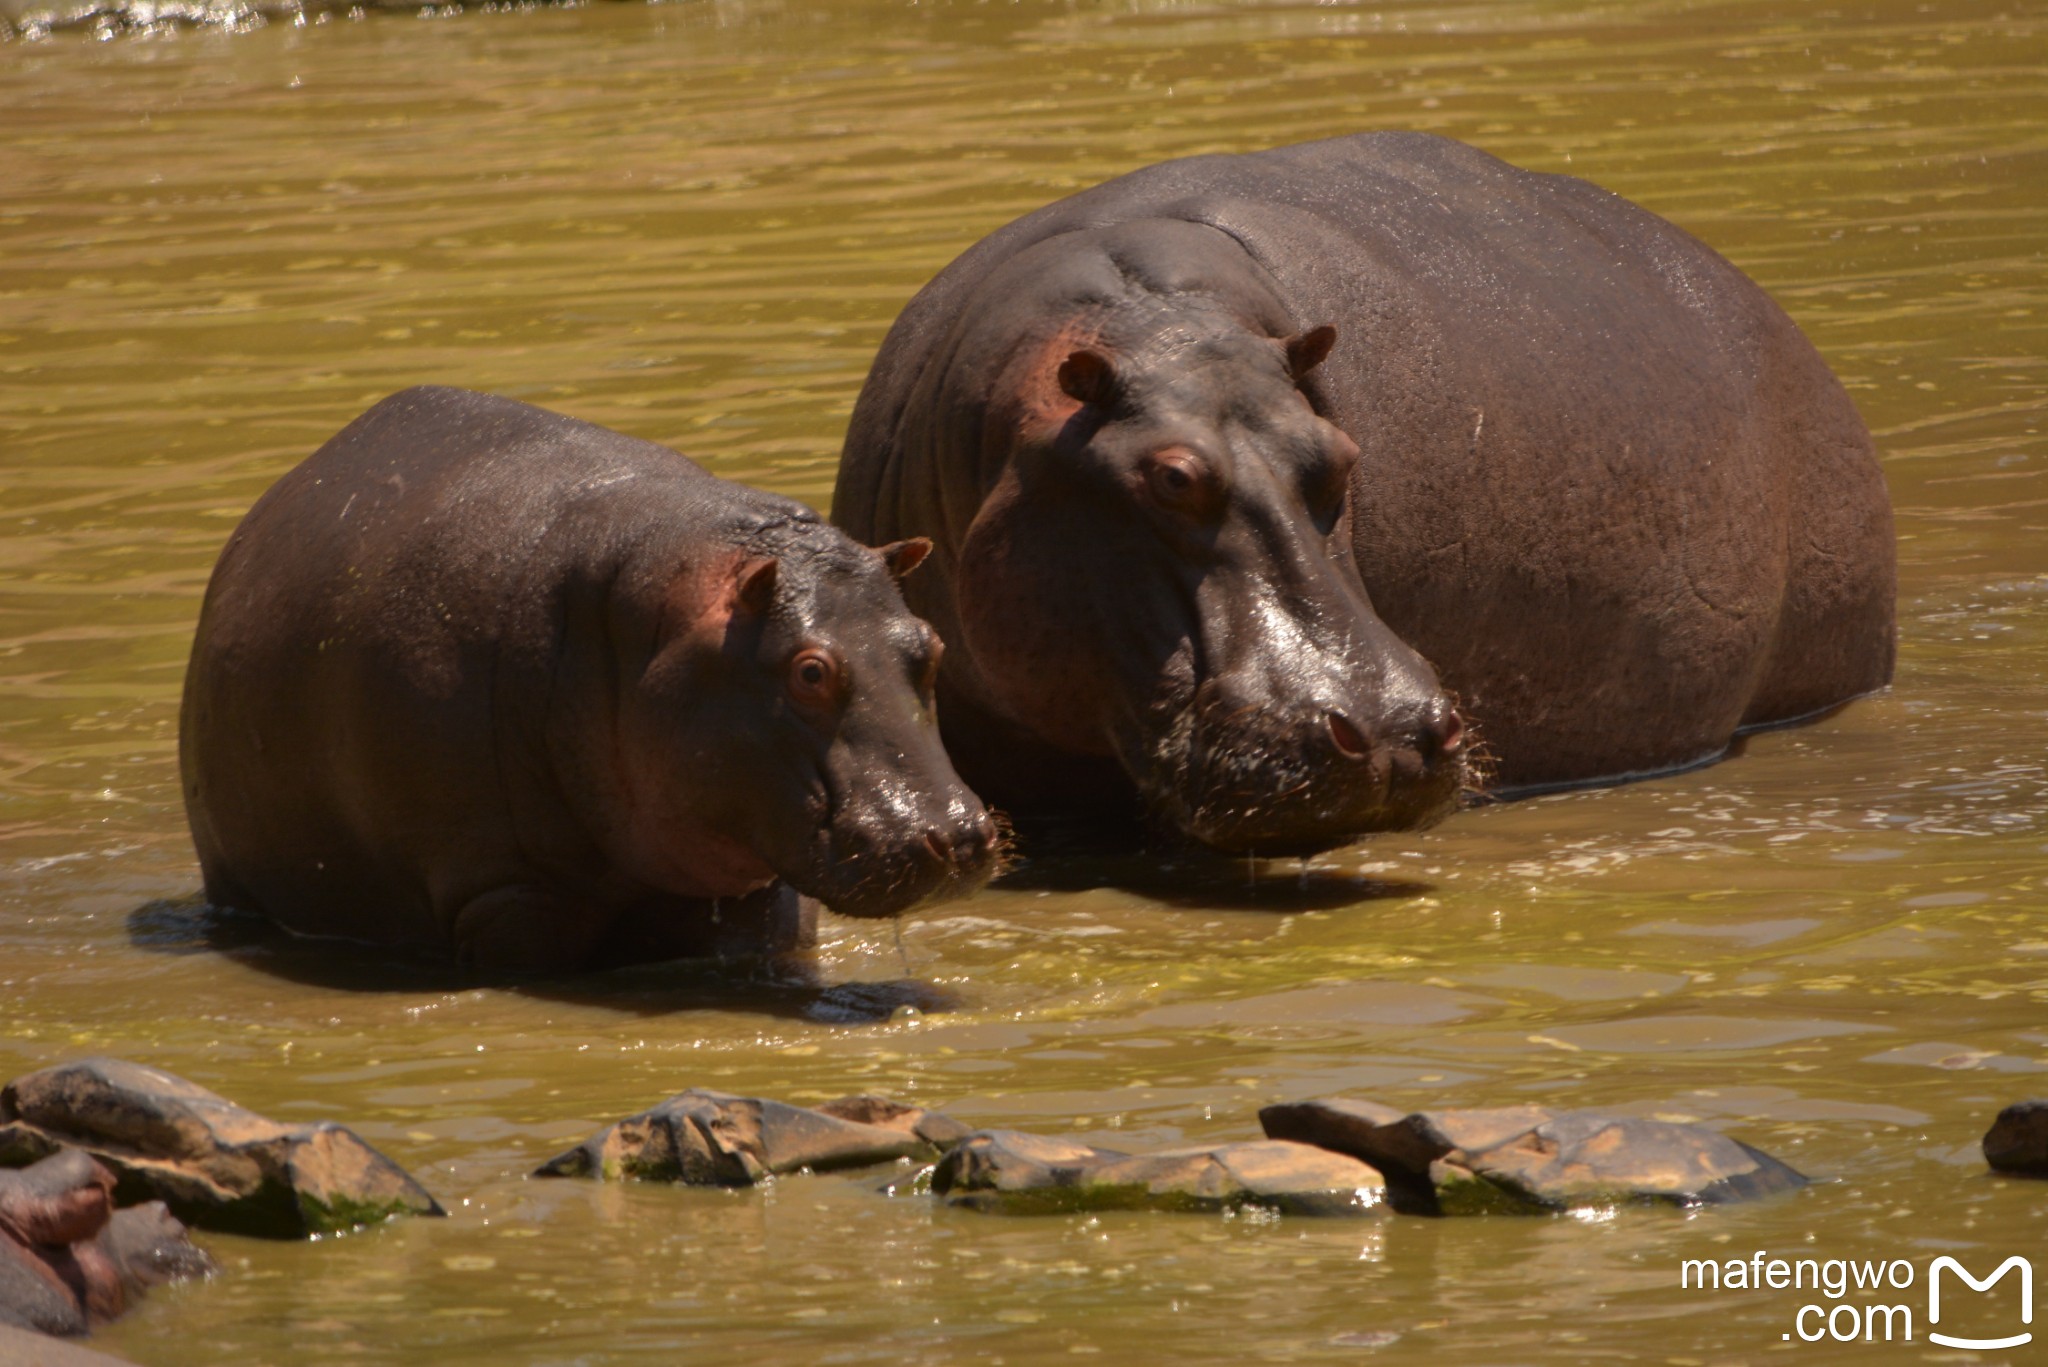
[956,307,1466,855]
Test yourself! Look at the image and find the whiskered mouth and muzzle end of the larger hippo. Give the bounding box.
[1124,701,1473,857]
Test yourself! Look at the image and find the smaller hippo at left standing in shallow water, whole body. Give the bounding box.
[178,387,997,976]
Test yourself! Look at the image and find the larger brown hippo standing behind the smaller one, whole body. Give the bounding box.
[834,133,1894,851]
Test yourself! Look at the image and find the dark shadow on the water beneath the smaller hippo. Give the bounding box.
[127,898,958,1025]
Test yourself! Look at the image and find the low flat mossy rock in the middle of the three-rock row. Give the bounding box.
[932,1129,1386,1215]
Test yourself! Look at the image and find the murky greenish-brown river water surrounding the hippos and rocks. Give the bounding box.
[0,0,2048,1365]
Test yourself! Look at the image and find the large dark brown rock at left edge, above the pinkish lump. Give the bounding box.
[0,1058,444,1238]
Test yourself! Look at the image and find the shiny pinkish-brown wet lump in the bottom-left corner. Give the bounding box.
[0,1148,213,1363]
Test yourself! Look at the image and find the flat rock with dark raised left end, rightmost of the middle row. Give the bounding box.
[1260,1099,1806,1215]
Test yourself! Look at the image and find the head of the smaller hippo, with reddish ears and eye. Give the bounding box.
[623,510,997,916]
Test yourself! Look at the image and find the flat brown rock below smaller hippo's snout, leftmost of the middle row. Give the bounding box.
[535,1088,969,1187]
